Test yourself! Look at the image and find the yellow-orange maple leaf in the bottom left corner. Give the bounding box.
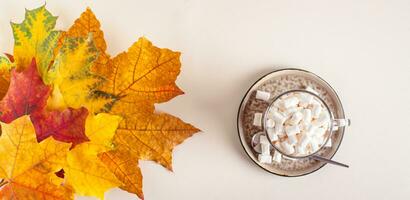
[0,116,73,200]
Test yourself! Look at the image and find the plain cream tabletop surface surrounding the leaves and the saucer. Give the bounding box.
[0,0,410,200]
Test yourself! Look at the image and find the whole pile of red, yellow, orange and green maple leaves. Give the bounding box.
[0,6,199,200]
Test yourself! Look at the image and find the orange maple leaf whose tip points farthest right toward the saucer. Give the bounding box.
[114,113,199,170]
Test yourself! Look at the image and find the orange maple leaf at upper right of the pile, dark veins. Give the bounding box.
[101,38,183,103]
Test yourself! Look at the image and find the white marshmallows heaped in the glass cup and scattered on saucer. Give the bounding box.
[253,89,331,163]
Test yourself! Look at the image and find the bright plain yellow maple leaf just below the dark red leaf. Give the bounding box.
[63,113,121,199]
